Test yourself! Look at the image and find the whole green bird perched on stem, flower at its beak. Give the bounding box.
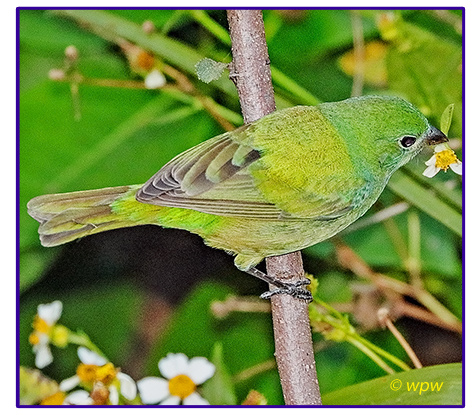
[28,96,447,300]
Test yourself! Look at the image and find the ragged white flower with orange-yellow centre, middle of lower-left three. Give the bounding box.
[59,347,137,405]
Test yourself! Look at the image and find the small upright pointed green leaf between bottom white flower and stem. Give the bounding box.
[201,343,237,405]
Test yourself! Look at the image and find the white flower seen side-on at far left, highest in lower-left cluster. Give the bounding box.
[29,300,63,369]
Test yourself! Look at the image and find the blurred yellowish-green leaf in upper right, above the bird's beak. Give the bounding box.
[381,15,462,136]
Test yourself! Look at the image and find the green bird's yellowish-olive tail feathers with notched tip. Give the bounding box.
[28,186,140,246]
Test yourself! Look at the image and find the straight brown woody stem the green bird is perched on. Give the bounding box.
[227,10,321,405]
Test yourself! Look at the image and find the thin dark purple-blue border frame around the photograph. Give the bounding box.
[15,6,466,409]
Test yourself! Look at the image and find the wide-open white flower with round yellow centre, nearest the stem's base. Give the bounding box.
[137,353,216,405]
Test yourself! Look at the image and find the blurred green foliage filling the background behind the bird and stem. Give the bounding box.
[18,10,462,404]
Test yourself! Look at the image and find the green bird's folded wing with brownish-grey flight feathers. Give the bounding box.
[136,126,364,220]
